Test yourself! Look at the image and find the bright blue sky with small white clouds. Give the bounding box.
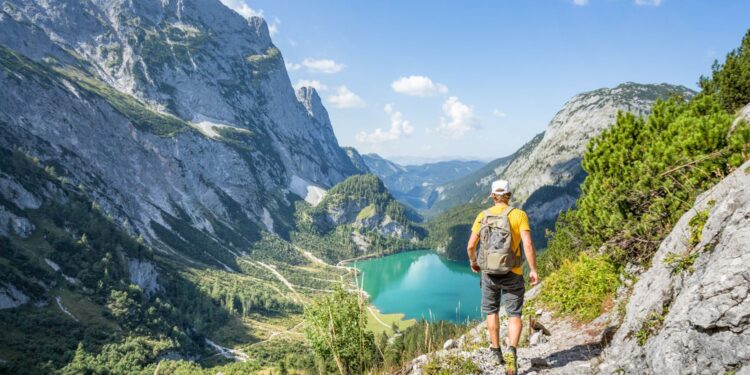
[222,0,750,164]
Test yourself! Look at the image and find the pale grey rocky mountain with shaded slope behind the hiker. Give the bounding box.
[425,82,695,258]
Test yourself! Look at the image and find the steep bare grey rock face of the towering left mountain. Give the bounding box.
[0,0,358,266]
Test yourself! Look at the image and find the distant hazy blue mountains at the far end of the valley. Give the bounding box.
[362,154,484,210]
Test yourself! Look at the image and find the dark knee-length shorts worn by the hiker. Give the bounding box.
[479,272,526,318]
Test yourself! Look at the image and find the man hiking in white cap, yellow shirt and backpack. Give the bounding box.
[466,180,539,375]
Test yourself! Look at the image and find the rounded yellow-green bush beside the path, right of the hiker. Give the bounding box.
[539,253,620,321]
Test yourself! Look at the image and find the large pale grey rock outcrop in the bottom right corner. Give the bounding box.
[599,162,750,374]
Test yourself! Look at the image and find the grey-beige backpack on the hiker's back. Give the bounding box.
[478,206,521,275]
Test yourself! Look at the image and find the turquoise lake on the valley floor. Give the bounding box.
[352,250,481,322]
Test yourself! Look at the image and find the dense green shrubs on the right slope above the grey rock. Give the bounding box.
[539,29,750,319]
